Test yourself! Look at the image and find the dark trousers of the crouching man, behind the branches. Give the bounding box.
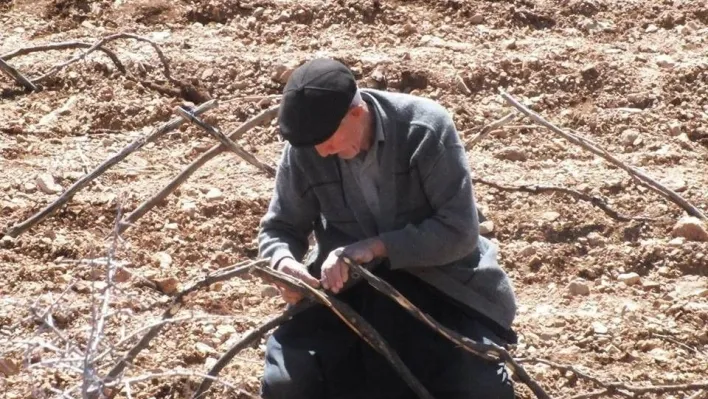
[261,270,514,399]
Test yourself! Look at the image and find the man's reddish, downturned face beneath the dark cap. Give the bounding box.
[315,107,364,159]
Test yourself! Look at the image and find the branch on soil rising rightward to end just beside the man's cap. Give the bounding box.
[121,106,279,231]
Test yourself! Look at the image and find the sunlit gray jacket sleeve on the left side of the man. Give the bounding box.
[258,146,318,267]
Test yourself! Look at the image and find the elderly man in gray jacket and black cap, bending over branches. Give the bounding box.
[259,59,516,399]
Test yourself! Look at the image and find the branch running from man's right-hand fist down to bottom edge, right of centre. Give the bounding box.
[340,254,550,399]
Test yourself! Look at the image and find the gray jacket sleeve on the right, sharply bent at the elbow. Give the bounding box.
[380,116,479,269]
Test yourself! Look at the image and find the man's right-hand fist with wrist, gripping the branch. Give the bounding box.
[322,238,386,294]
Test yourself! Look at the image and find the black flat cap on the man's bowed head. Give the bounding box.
[278,58,357,147]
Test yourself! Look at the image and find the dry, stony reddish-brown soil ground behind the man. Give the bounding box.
[0,0,708,399]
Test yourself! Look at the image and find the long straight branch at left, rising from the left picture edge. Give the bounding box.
[5,101,216,238]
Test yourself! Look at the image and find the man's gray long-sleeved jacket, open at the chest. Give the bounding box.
[259,89,516,329]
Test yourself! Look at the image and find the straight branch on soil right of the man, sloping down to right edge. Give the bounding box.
[499,88,708,220]
